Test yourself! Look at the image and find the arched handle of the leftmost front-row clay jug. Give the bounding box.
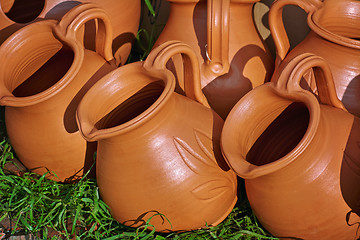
[54,3,113,61]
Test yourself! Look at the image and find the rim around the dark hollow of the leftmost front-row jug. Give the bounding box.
[0,19,84,107]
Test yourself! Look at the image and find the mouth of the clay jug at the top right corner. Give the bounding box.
[307,1,360,49]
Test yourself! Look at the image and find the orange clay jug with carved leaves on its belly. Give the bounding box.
[77,41,237,231]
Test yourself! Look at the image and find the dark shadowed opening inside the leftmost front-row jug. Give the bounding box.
[12,46,74,97]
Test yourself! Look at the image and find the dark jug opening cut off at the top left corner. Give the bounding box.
[0,0,45,23]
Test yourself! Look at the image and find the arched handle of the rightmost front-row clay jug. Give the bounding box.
[276,53,346,111]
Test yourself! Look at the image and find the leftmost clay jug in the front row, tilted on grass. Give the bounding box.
[0,4,115,181]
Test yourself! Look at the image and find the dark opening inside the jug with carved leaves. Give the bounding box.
[95,80,165,130]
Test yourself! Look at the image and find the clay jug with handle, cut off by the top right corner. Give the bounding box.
[269,0,360,117]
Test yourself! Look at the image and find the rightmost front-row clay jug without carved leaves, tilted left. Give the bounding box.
[221,54,360,240]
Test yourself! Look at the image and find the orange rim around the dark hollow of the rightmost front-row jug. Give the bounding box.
[221,82,321,179]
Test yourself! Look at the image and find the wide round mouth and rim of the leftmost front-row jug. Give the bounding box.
[0,20,83,107]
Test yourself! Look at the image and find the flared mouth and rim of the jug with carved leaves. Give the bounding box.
[76,62,175,141]
